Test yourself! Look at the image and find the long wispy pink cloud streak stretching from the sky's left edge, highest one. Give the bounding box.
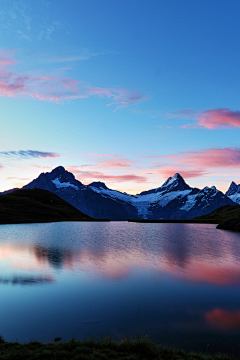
[0,52,147,111]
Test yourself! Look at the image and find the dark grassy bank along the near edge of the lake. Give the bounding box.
[0,337,231,360]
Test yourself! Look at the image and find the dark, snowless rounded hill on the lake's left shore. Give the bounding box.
[0,189,96,224]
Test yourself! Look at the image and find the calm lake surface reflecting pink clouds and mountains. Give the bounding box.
[0,222,240,355]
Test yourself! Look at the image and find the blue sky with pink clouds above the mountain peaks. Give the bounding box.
[0,0,240,194]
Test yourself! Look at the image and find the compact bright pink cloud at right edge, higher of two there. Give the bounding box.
[166,108,240,130]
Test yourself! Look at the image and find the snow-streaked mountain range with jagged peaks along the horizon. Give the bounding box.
[1,166,240,220]
